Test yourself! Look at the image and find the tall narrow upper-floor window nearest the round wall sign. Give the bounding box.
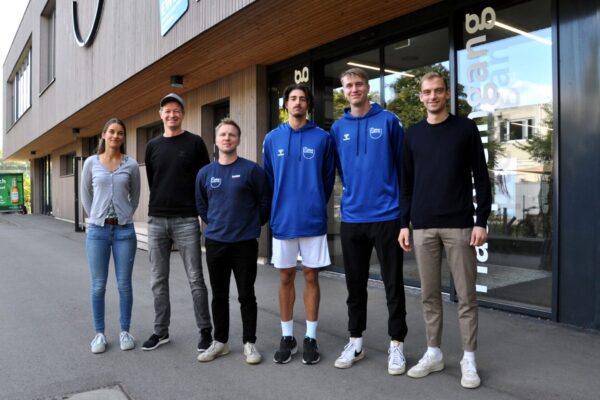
[40,0,56,91]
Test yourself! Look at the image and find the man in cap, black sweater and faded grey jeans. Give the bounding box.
[142,93,212,352]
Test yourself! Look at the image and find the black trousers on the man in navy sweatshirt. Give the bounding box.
[205,238,258,343]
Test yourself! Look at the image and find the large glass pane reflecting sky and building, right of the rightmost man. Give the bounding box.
[457,0,554,312]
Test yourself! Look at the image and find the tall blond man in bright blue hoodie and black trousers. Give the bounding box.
[331,68,407,375]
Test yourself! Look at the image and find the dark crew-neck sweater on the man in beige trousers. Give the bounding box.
[400,114,492,229]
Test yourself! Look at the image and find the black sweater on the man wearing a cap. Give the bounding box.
[145,131,209,217]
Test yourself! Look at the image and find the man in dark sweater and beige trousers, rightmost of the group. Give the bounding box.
[398,72,491,388]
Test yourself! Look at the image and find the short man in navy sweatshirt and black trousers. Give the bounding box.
[196,118,271,364]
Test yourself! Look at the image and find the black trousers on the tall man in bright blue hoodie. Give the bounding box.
[340,220,407,342]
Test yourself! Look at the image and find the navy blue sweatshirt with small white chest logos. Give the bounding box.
[196,157,271,243]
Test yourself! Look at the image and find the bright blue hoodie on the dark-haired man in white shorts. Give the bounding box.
[263,121,335,240]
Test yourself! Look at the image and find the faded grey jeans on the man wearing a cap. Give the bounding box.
[148,217,212,336]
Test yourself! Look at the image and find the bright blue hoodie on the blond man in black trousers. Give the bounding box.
[331,103,404,223]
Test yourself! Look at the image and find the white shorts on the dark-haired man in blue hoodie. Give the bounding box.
[271,235,331,269]
